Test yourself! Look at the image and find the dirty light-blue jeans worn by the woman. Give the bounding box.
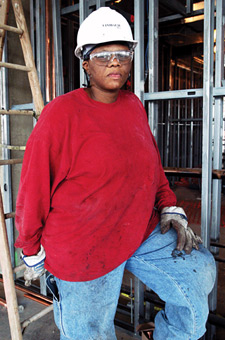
[46,225,216,340]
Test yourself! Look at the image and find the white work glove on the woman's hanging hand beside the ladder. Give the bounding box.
[21,245,46,286]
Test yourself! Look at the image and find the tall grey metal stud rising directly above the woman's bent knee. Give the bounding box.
[201,0,214,249]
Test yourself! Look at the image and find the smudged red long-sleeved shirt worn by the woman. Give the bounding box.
[15,89,176,281]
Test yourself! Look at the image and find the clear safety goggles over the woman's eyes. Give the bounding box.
[90,51,134,66]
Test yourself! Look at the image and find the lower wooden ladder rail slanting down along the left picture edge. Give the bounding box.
[0,190,23,340]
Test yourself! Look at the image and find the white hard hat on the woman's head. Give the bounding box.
[74,7,137,59]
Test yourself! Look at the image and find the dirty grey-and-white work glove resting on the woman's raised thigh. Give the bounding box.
[161,207,202,254]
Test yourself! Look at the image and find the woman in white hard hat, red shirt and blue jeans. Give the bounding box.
[16,7,215,340]
